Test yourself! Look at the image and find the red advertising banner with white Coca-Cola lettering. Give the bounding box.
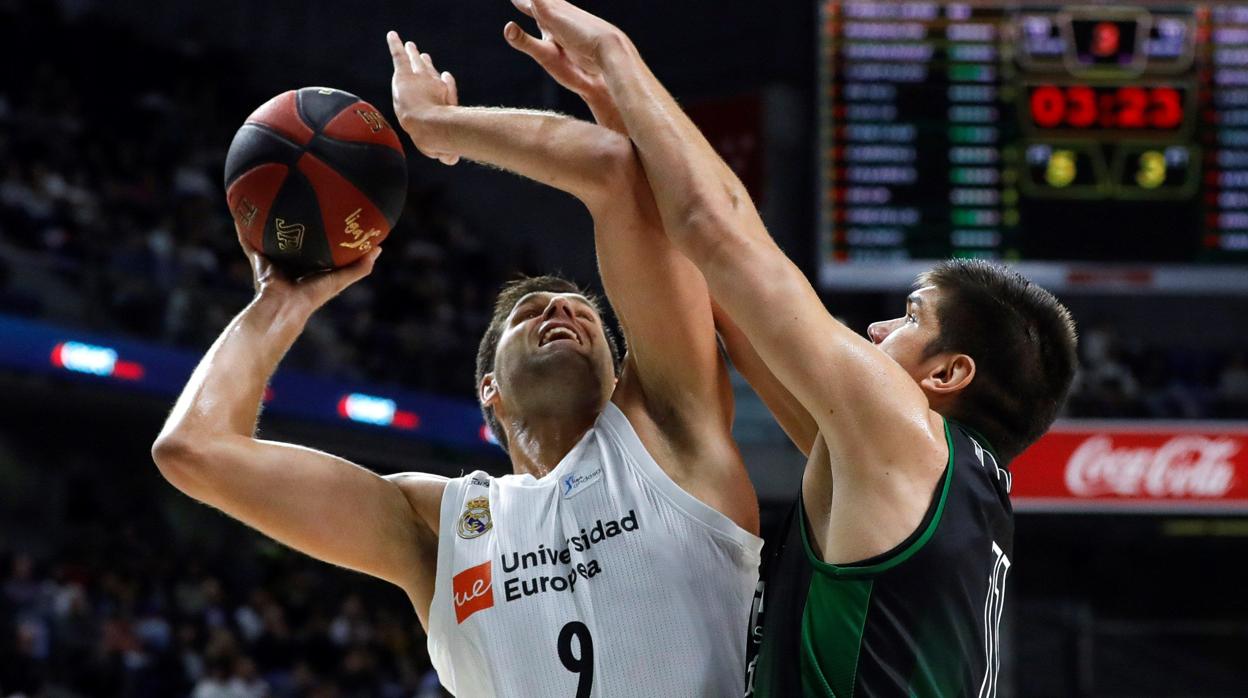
[1010,422,1248,513]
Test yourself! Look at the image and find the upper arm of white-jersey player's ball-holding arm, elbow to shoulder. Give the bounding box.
[166,436,432,588]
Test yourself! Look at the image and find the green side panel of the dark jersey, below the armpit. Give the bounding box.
[800,576,875,698]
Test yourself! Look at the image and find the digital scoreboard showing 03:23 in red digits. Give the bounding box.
[819,1,1248,291]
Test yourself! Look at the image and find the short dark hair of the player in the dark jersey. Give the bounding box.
[919,260,1078,462]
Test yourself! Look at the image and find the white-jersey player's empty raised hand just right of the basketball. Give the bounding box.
[386,31,459,165]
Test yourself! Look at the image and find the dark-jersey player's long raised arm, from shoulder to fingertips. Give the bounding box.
[509,0,943,469]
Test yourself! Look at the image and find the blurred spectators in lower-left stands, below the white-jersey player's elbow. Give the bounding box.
[0,549,444,698]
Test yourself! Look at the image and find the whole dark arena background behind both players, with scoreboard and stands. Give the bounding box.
[0,0,1248,698]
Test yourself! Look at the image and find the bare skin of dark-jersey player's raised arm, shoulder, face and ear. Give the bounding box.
[506,0,975,562]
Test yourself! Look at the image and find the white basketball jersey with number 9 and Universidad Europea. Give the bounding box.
[429,403,763,698]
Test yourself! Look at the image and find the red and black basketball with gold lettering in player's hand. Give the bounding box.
[225,87,407,277]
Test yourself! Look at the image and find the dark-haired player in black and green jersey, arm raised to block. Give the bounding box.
[501,0,1076,698]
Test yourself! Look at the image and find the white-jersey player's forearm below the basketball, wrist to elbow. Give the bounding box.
[161,295,310,440]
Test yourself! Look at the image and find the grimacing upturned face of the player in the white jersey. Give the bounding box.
[494,292,615,408]
